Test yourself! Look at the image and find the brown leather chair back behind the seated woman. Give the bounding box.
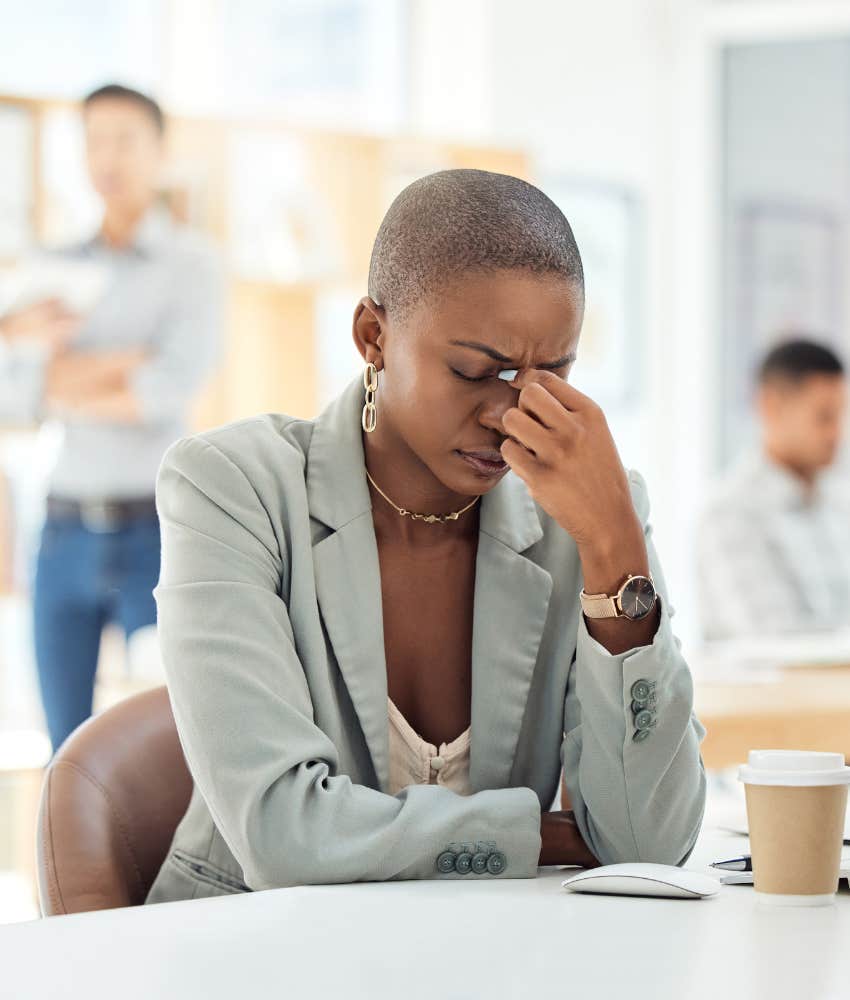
[36,687,192,916]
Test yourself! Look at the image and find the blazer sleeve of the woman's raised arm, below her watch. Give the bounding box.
[561,471,706,865]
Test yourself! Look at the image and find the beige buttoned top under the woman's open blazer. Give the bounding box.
[387,698,472,795]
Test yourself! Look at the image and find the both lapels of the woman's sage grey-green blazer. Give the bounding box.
[307,378,552,791]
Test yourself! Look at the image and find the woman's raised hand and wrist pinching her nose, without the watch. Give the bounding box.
[501,369,658,654]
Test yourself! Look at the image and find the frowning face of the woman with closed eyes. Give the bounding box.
[355,271,584,495]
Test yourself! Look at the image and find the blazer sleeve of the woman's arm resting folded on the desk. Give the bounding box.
[154,436,541,889]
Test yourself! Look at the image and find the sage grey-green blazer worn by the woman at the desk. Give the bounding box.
[147,378,705,903]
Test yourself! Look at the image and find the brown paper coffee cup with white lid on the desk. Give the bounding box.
[738,750,850,906]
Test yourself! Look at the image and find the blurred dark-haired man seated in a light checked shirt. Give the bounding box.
[698,340,850,639]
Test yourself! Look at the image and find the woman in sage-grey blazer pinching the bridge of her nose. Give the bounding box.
[147,170,705,902]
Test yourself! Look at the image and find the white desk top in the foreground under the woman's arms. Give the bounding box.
[0,833,850,1000]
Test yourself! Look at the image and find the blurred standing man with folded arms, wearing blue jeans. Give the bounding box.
[0,85,223,750]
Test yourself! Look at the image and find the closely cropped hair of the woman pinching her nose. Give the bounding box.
[369,170,584,314]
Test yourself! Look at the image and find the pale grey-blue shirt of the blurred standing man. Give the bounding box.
[0,209,224,499]
